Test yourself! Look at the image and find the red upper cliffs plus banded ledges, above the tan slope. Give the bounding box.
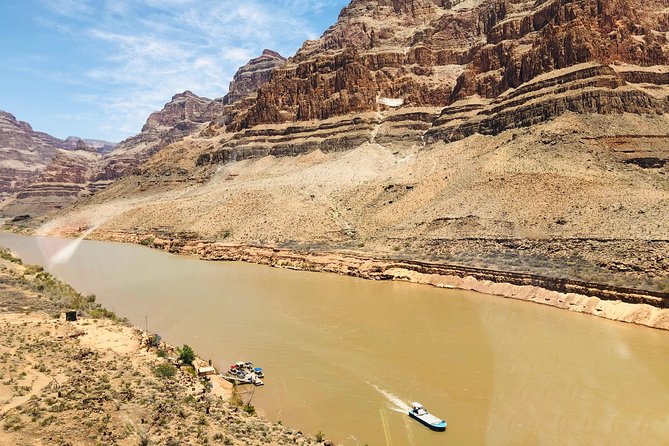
[188,0,669,166]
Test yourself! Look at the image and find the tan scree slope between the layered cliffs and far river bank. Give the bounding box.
[35,114,669,291]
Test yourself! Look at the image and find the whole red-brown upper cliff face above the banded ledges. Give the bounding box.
[228,0,669,131]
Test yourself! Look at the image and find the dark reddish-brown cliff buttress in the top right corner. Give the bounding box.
[454,0,669,99]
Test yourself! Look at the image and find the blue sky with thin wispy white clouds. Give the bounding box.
[0,0,349,142]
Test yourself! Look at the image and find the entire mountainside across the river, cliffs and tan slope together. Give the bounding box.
[31,0,669,296]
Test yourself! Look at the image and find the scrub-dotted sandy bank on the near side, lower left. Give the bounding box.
[0,250,330,445]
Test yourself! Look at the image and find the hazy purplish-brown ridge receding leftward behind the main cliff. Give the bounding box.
[1,50,285,220]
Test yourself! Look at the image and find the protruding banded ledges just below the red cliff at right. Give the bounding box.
[426,63,669,142]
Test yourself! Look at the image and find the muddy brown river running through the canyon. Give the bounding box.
[0,234,669,446]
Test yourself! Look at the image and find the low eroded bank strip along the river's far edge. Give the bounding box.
[82,230,669,330]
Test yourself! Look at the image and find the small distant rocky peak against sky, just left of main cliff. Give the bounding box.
[223,50,286,105]
